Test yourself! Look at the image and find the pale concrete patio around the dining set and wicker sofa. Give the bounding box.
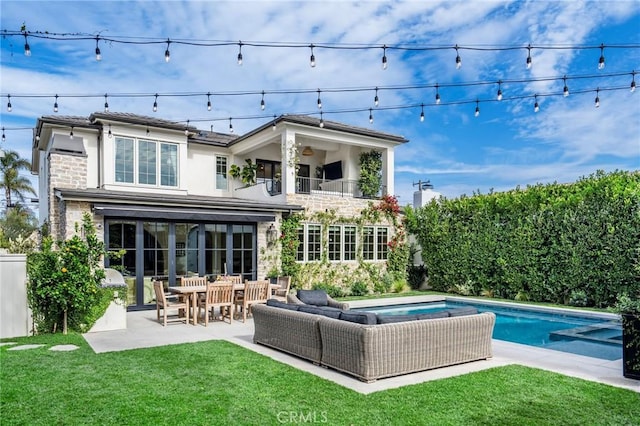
[84,296,640,394]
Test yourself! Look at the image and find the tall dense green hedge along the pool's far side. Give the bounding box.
[406,171,640,307]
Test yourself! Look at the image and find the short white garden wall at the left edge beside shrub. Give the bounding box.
[0,254,32,338]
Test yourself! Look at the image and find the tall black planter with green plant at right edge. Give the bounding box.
[616,294,640,380]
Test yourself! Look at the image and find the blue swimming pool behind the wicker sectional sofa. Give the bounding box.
[355,300,622,360]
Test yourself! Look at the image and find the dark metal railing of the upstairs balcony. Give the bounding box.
[264,176,386,198]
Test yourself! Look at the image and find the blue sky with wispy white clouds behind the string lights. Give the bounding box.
[0,0,640,205]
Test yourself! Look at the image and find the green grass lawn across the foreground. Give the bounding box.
[0,334,640,425]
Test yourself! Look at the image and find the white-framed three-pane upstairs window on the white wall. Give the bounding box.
[115,137,178,187]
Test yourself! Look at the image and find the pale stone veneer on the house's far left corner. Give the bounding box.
[47,152,91,239]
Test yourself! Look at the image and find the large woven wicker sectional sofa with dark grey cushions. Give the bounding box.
[253,294,495,382]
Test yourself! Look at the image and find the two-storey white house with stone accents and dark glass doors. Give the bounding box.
[32,112,407,309]
